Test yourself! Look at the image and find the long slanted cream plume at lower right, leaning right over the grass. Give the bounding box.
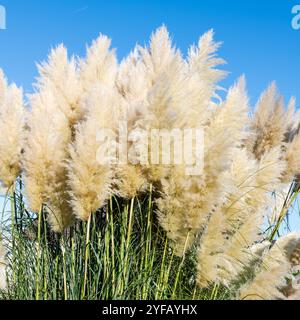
[218,148,285,284]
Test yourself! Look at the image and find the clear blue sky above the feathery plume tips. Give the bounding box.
[0,0,300,230]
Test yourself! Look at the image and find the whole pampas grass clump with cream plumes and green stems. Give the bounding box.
[0,26,300,300]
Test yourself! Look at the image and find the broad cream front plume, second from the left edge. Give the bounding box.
[23,90,71,230]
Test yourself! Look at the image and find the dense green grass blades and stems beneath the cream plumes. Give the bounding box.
[0,181,230,300]
